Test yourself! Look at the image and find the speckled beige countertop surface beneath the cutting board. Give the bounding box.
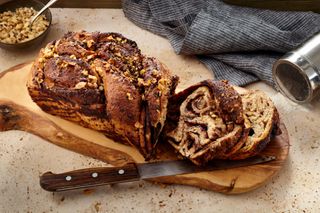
[0,9,320,213]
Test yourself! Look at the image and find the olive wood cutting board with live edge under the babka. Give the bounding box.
[0,63,289,194]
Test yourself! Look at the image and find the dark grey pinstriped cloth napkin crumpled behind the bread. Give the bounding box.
[122,0,320,86]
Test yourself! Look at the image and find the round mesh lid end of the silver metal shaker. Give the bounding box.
[272,52,320,103]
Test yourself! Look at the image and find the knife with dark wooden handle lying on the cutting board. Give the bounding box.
[40,156,276,192]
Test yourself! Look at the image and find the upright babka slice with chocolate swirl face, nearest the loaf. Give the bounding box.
[164,80,248,165]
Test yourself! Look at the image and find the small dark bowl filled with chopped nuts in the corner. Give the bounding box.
[0,0,52,50]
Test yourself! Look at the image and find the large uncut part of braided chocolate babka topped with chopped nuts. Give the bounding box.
[27,31,177,158]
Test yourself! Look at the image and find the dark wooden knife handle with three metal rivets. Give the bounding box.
[40,163,140,192]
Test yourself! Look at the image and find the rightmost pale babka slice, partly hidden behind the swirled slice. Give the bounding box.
[228,90,281,160]
